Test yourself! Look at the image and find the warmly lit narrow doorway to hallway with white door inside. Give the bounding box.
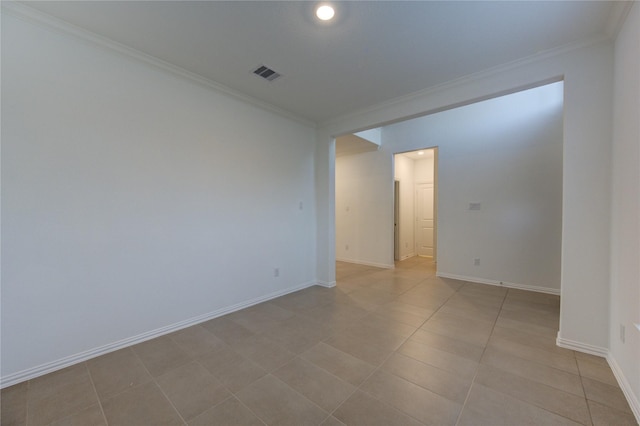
[393,147,438,263]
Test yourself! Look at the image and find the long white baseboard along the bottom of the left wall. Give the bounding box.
[0,281,316,389]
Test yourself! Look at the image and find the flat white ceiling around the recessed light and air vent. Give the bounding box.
[26,1,619,123]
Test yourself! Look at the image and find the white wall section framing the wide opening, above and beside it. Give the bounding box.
[316,40,613,351]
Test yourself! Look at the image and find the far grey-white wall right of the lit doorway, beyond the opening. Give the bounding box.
[383,83,562,289]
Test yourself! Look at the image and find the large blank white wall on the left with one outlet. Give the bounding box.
[2,14,316,377]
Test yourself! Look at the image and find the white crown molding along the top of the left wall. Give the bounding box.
[1,0,316,129]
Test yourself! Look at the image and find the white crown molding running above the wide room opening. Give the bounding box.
[318,33,611,128]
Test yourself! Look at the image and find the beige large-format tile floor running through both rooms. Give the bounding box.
[1,258,636,426]
